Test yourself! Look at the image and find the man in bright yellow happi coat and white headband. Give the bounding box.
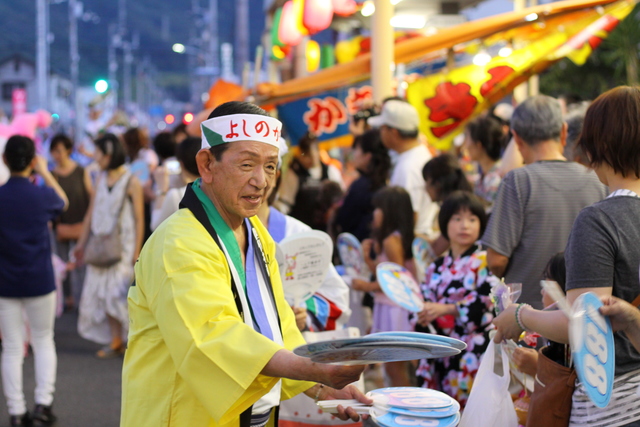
[121,102,372,427]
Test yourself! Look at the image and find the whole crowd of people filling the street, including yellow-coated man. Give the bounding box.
[0,87,640,427]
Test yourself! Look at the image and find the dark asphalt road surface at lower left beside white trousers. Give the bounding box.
[0,312,123,427]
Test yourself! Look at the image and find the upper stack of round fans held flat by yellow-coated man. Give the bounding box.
[293,332,467,365]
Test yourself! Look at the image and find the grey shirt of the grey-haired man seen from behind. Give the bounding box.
[481,161,606,309]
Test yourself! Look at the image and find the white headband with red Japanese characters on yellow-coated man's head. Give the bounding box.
[200,114,282,148]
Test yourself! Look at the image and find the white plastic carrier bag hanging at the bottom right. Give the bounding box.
[459,340,518,427]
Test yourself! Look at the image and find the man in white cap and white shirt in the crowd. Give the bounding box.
[367,99,438,237]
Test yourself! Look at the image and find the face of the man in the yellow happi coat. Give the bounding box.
[203,141,278,221]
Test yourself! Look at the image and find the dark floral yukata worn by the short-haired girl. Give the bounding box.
[416,245,493,408]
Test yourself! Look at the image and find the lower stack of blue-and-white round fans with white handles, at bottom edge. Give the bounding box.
[318,387,460,427]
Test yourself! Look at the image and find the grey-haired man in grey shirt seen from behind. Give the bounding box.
[481,95,606,308]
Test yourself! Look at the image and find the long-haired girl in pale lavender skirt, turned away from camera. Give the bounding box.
[351,187,416,387]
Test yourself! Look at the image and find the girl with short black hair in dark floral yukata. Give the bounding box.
[416,191,493,408]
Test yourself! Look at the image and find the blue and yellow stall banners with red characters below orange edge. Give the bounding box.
[252,0,635,150]
